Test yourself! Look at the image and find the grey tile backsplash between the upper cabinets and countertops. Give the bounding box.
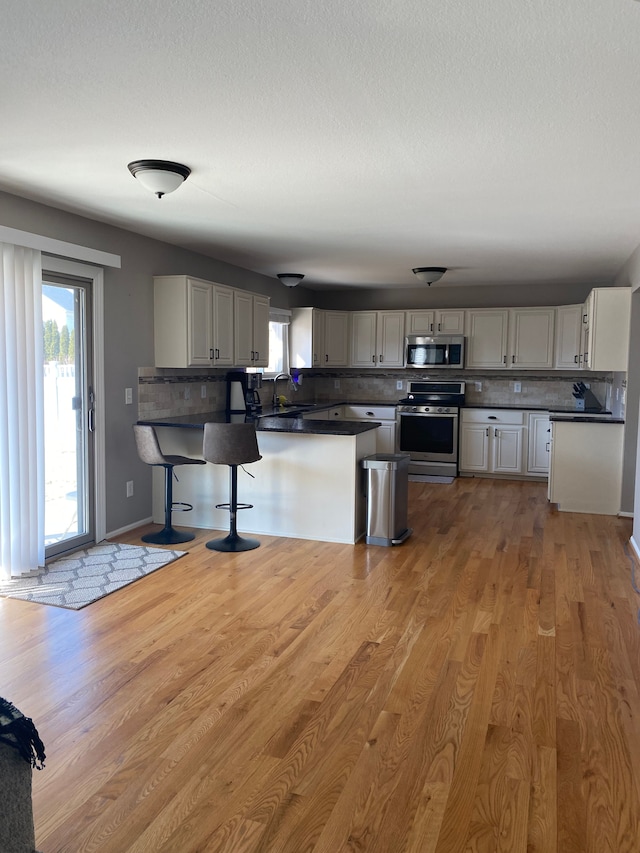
[138,367,625,419]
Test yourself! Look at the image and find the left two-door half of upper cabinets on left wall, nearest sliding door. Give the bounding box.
[153,275,233,367]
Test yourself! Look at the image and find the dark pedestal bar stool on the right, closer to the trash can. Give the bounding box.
[202,423,262,551]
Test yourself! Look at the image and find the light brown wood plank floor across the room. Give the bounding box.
[0,479,640,853]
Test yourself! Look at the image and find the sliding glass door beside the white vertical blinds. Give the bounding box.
[42,272,95,558]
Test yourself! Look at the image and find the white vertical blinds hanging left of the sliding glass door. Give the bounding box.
[0,243,44,580]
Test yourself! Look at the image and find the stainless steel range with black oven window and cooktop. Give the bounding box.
[396,381,465,477]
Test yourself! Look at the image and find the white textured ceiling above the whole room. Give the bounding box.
[0,0,640,289]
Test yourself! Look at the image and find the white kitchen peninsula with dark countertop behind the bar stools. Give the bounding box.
[139,412,379,544]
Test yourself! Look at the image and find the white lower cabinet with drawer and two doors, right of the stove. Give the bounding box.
[459,409,526,475]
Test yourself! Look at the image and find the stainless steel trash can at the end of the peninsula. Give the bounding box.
[361,453,413,545]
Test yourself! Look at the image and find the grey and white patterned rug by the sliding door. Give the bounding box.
[0,539,187,610]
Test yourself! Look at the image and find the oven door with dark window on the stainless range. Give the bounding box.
[397,412,458,462]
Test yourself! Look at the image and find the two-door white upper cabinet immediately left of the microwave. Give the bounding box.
[350,311,405,367]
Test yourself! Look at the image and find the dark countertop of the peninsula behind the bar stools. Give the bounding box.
[138,412,380,436]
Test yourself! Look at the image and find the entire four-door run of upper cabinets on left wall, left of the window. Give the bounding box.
[153,275,269,367]
